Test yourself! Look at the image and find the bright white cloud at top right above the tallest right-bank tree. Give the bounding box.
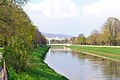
[82,0,120,18]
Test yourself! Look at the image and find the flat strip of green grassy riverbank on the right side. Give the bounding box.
[69,46,120,61]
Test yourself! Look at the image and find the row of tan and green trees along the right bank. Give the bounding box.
[71,17,120,46]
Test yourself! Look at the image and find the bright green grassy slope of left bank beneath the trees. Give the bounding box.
[9,46,67,80]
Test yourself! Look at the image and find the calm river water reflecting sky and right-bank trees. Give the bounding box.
[44,48,120,80]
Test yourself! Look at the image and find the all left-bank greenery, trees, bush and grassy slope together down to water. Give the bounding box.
[0,0,66,80]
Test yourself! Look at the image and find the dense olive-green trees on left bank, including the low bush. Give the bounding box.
[0,0,46,72]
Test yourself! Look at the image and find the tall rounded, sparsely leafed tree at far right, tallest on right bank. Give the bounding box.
[102,17,120,45]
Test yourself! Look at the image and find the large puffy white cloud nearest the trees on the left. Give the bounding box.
[25,0,80,19]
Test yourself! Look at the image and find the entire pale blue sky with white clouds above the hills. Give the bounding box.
[24,0,120,36]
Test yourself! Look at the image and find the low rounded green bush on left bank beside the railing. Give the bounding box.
[3,46,28,72]
